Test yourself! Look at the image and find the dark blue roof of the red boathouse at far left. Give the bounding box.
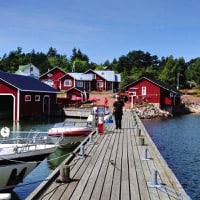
[0,72,58,93]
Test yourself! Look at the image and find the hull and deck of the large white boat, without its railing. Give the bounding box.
[0,144,57,191]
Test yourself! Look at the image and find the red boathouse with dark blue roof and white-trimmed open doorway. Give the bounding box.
[0,72,58,121]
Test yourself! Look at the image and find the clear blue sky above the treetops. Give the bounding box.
[0,0,200,64]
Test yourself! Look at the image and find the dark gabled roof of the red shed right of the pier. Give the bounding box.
[124,77,180,94]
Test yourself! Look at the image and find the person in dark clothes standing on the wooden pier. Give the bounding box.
[113,95,124,129]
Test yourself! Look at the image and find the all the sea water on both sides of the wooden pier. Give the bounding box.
[0,114,200,200]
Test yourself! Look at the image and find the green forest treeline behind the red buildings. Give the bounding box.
[0,47,200,89]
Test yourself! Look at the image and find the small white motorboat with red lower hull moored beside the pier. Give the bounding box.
[48,121,93,136]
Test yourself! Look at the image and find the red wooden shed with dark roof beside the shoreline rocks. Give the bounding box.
[124,77,180,110]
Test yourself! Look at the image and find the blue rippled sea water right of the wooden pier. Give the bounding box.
[143,114,200,200]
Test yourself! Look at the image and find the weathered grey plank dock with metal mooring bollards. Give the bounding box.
[27,111,189,200]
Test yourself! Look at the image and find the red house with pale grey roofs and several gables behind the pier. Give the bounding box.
[39,67,121,91]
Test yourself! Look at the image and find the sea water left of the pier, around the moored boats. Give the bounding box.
[0,118,73,200]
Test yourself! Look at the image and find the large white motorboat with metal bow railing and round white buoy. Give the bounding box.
[0,127,57,191]
